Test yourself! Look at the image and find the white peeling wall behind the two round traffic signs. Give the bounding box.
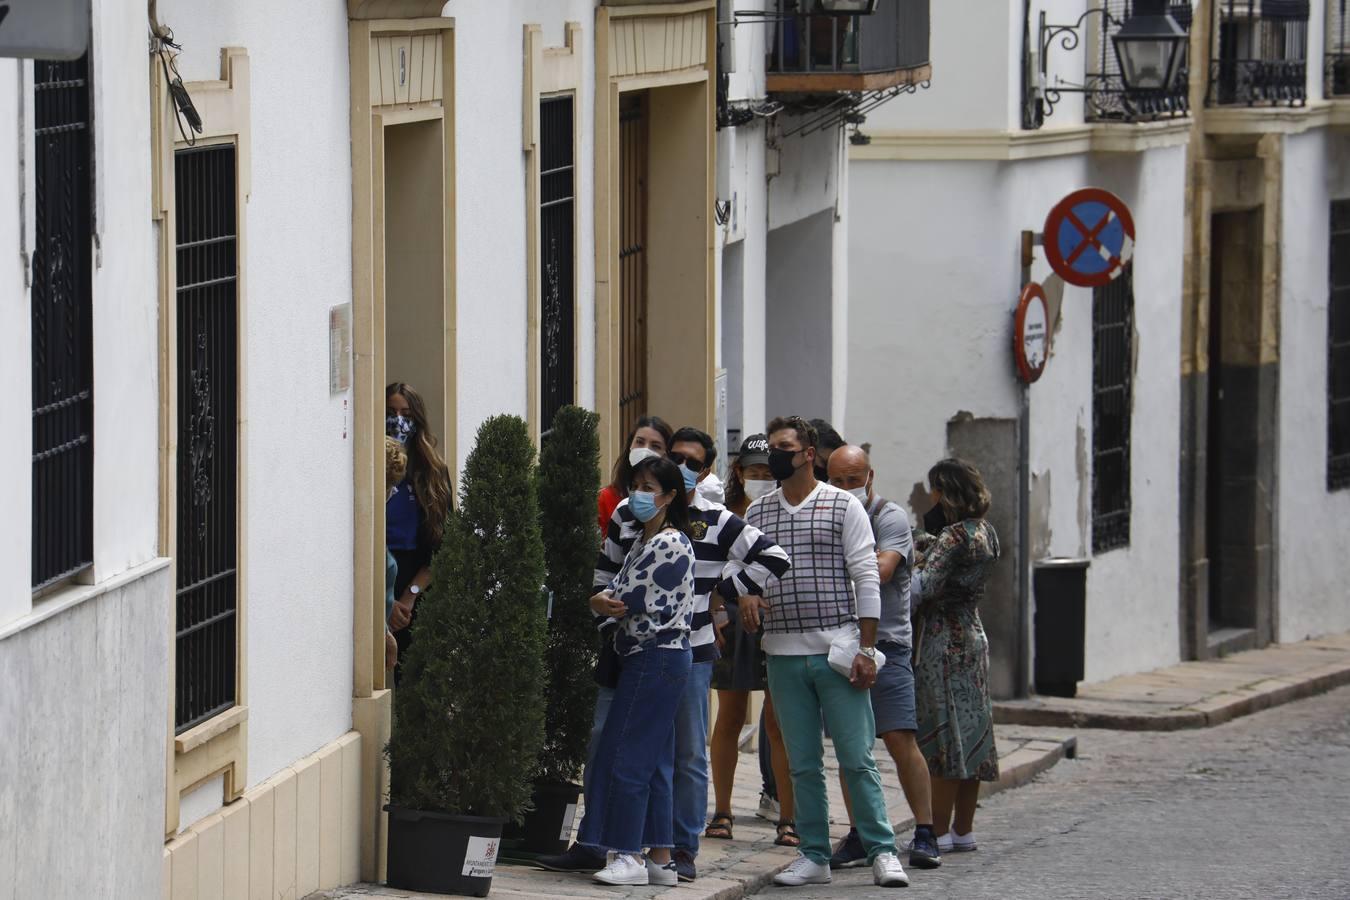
[836,0,1185,681]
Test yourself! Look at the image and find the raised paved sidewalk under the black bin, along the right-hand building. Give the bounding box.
[994,633,1350,731]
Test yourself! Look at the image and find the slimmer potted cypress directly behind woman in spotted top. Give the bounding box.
[516,406,601,854]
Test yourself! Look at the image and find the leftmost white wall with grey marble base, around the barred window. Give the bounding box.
[0,0,173,899]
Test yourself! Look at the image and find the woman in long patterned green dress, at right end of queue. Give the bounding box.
[910,459,999,853]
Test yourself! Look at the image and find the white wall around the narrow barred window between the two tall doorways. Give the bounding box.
[448,0,595,463]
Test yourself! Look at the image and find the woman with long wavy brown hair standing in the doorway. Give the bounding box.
[385,382,450,653]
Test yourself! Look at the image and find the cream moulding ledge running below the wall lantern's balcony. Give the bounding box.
[849,119,1191,161]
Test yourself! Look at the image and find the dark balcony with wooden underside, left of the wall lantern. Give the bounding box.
[767,0,932,93]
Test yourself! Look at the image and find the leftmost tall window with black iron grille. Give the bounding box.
[32,54,93,591]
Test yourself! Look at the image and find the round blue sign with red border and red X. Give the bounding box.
[1041,188,1134,287]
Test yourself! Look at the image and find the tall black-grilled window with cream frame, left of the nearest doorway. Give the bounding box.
[174,144,239,733]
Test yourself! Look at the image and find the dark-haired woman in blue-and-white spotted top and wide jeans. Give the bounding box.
[576,456,694,887]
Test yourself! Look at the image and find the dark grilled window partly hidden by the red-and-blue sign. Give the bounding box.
[1092,266,1134,553]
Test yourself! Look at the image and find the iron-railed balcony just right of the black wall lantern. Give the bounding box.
[1208,0,1308,107]
